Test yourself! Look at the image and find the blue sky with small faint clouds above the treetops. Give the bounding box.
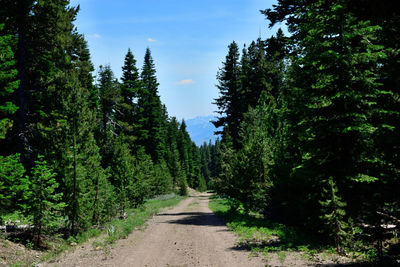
[71,0,282,119]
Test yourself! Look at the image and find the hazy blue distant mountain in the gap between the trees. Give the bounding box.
[185,115,217,146]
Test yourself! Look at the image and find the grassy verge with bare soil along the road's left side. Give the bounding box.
[0,194,185,266]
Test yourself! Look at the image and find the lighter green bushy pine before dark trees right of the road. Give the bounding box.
[236,92,276,214]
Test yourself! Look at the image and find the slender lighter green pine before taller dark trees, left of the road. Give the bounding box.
[54,74,105,234]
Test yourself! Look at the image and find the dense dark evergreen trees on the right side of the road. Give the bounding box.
[210,0,400,257]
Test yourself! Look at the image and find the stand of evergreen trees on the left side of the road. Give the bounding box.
[0,0,206,245]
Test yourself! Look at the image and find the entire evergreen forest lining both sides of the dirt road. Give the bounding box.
[0,0,400,264]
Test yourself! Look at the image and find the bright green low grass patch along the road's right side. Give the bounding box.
[209,196,376,263]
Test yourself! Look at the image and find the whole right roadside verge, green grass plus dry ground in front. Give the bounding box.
[209,195,396,266]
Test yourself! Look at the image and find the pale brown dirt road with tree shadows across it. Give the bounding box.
[44,193,265,267]
